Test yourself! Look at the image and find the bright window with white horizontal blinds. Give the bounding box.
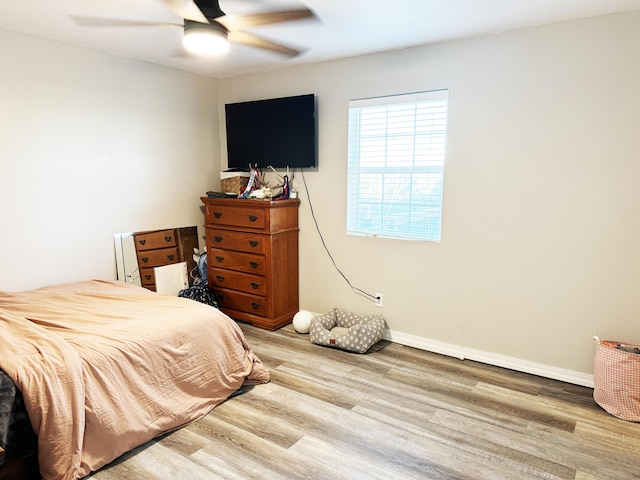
[347,90,449,241]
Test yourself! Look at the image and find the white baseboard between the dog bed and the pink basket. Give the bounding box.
[384,330,593,388]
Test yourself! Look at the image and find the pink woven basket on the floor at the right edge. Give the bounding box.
[593,337,640,422]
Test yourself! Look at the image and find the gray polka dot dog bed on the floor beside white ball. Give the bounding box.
[309,308,386,353]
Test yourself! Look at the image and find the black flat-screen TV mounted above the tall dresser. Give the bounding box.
[225,94,318,170]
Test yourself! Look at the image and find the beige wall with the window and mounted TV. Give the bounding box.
[218,13,640,383]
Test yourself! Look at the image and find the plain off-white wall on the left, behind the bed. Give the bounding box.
[0,31,219,290]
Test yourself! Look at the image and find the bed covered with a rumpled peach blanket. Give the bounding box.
[0,280,269,480]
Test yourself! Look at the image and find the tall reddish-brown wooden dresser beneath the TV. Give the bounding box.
[202,197,300,330]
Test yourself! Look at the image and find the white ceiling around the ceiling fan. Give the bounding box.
[0,0,640,78]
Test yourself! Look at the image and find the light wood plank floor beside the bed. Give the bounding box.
[91,324,640,480]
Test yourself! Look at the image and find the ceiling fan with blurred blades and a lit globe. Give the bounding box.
[69,0,316,57]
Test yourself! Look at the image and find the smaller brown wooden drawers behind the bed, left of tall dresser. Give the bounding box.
[133,227,198,291]
